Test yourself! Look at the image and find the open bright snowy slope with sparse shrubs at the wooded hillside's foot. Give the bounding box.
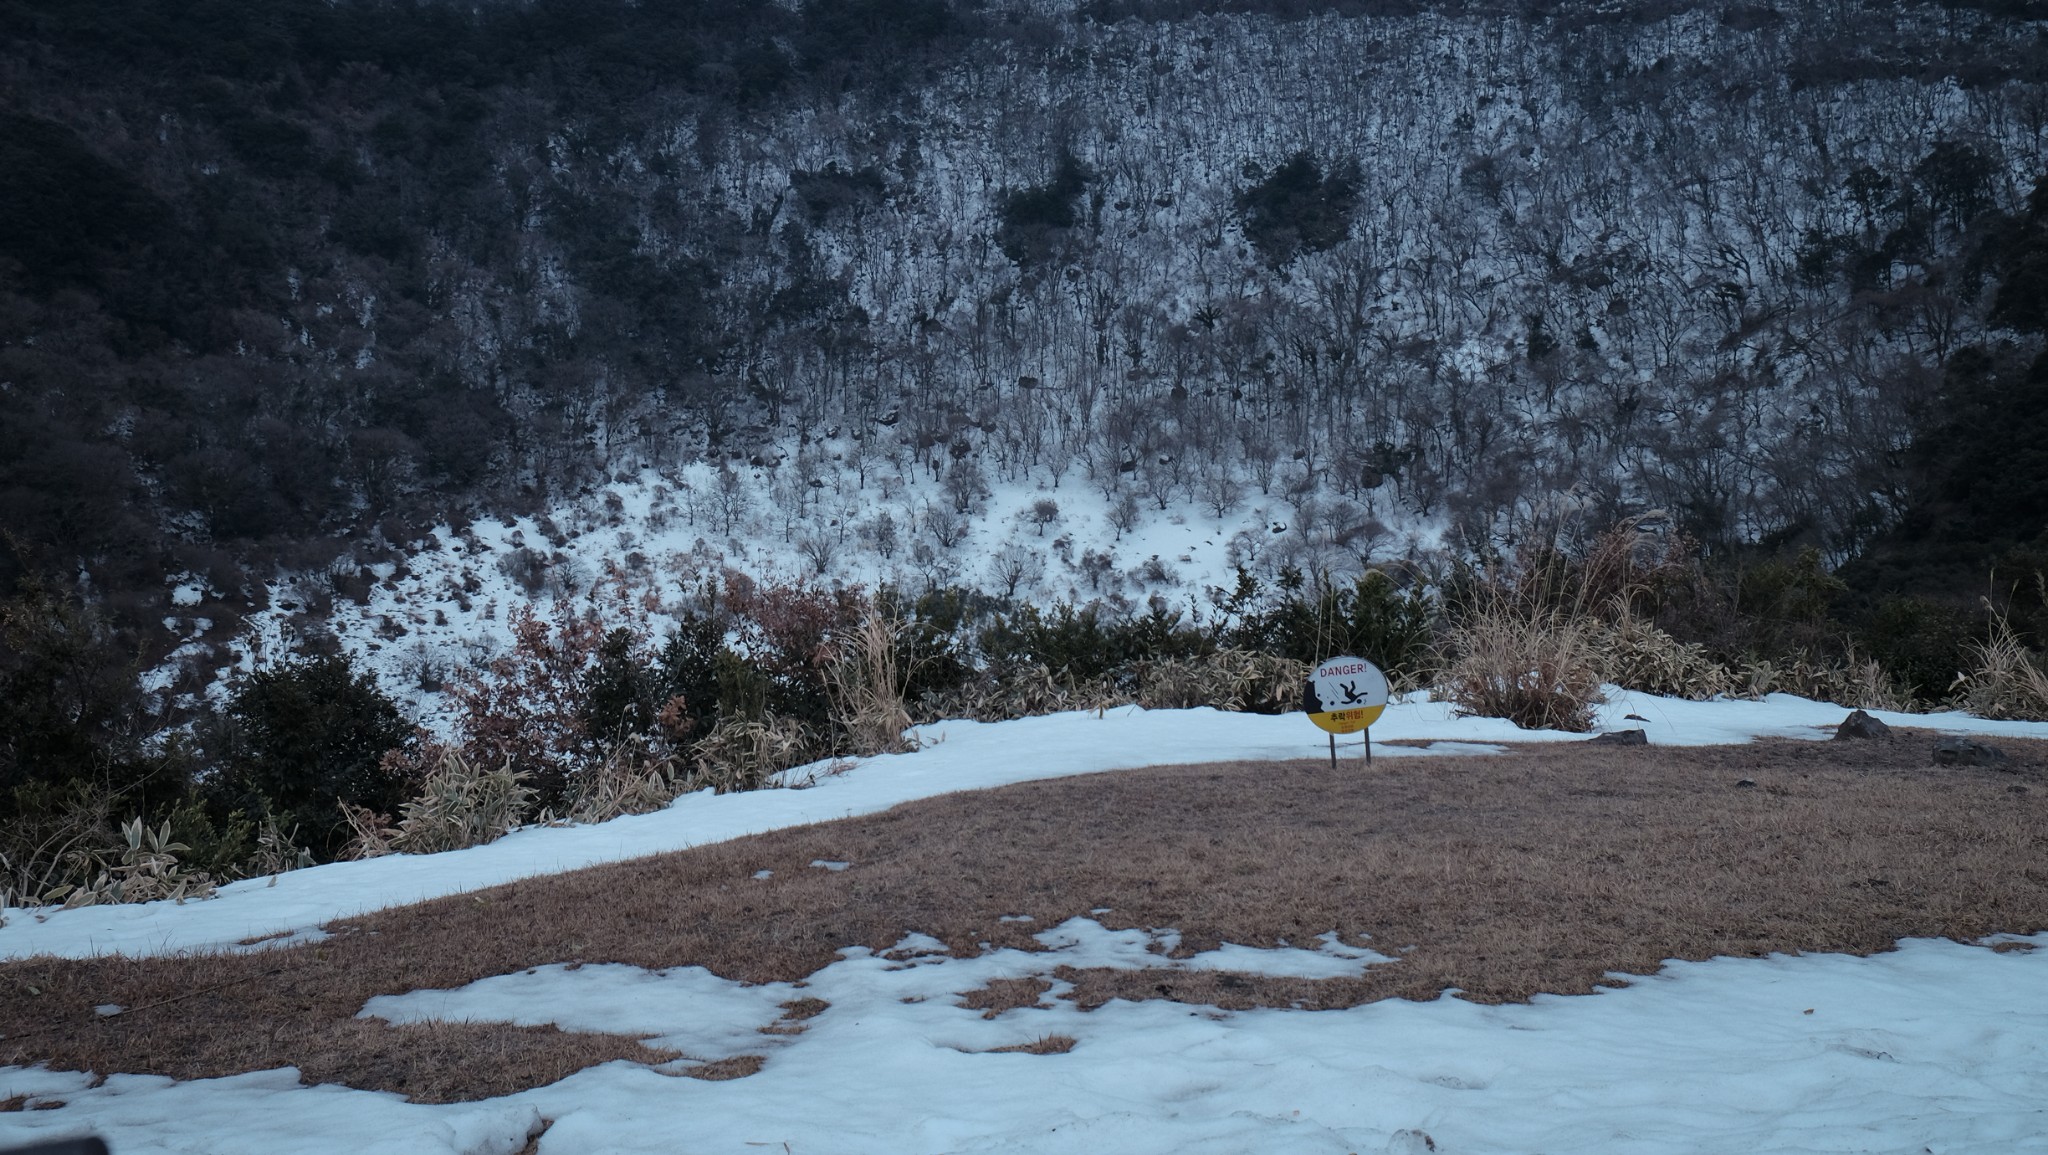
[176,456,1442,725]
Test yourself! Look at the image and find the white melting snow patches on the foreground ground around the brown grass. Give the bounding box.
[0,692,2048,1155]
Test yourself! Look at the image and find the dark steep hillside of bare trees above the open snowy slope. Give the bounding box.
[12,0,2048,638]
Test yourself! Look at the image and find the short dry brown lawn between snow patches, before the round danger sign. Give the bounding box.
[0,733,2048,1100]
